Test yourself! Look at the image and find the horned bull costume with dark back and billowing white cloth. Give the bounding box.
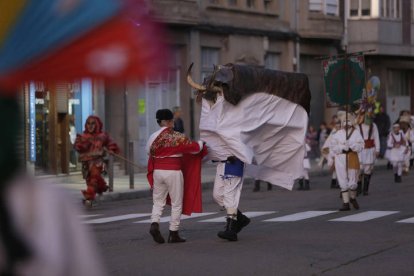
[187,63,311,189]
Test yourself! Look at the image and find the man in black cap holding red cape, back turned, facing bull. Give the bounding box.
[147,109,206,243]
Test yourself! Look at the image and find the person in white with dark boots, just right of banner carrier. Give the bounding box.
[357,114,380,195]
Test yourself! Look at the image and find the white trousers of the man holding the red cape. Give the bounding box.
[151,170,184,231]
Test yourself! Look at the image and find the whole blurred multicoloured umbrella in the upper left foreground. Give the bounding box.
[0,0,167,89]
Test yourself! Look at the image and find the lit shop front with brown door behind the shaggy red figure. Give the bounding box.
[24,79,93,175]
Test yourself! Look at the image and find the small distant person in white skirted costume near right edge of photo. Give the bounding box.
[387,124,409,183]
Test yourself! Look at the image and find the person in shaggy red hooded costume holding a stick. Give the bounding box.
[74,116,120,205]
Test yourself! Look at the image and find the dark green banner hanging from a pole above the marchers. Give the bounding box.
[322,54,365,107]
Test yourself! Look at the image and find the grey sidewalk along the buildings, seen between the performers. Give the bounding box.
[50,159,387,201]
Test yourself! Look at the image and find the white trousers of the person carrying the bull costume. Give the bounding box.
[213,163,243,214]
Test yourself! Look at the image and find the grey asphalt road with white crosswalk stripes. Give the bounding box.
[83,170,414,276]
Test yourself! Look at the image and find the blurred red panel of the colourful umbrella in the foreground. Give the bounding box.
[0,13,168,90]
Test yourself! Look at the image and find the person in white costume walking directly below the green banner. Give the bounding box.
[331,120,364,211]
